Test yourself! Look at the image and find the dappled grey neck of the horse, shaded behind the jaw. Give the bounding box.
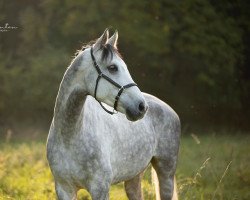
[54,62,87,133]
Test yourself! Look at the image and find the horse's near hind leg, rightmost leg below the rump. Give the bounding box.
[152,158,178,200]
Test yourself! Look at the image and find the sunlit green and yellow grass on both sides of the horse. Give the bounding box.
[0,134,250,200]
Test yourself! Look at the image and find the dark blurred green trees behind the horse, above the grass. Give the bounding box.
[0,0,250,129]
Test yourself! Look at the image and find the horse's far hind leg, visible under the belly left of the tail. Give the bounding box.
[124,173,143,200]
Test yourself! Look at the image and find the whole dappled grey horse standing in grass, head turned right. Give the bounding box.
[47,30,180,200]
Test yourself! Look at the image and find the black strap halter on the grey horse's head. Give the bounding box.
[90,47,137,115]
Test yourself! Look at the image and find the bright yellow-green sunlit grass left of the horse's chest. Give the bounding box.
[0,142,55,200]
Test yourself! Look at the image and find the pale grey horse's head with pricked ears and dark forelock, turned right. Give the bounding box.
[80,30,148,121]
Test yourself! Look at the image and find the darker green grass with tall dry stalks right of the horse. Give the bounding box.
[177,134,250,200]
